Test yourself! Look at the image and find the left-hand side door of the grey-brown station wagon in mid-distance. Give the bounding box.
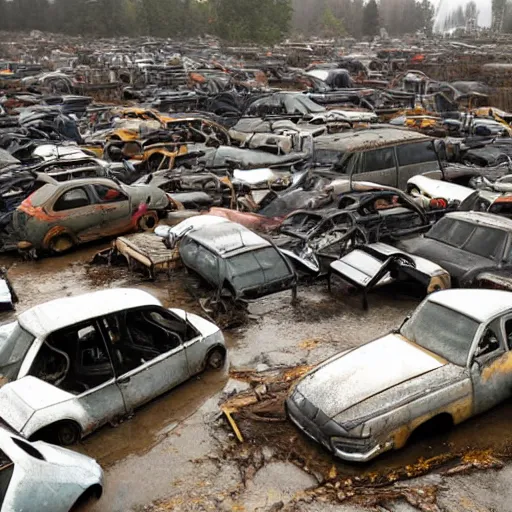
[352,147,398,187]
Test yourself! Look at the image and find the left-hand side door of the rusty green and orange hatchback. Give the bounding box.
[49,185,103,241]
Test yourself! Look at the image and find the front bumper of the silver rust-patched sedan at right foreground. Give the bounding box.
[286,398,393,462]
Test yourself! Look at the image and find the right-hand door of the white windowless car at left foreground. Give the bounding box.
[104,307,190,411]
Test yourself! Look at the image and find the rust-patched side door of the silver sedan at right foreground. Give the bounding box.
[471,315,512,414]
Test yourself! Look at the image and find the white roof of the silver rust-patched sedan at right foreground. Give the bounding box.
[428,289,512,322]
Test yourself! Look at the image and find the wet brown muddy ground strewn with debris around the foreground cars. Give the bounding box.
[0,246,512,512]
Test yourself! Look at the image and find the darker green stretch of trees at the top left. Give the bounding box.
[0,0,292,44]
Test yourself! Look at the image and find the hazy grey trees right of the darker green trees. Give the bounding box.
[292,0,435,38]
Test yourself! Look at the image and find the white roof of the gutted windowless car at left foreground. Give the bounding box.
[18,288,161,338]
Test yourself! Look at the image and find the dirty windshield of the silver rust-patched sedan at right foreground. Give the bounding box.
[400,300,480,366]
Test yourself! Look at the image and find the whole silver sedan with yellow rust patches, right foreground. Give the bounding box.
[286,290,512,462]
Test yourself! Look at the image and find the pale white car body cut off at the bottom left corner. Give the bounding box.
[0,428,103,512]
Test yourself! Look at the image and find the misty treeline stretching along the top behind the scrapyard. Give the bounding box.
[0,0,456,44]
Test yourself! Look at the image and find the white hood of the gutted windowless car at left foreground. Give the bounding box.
[0,376,74,432]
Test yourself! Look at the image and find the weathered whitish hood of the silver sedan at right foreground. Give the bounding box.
[296,334,447,418]
